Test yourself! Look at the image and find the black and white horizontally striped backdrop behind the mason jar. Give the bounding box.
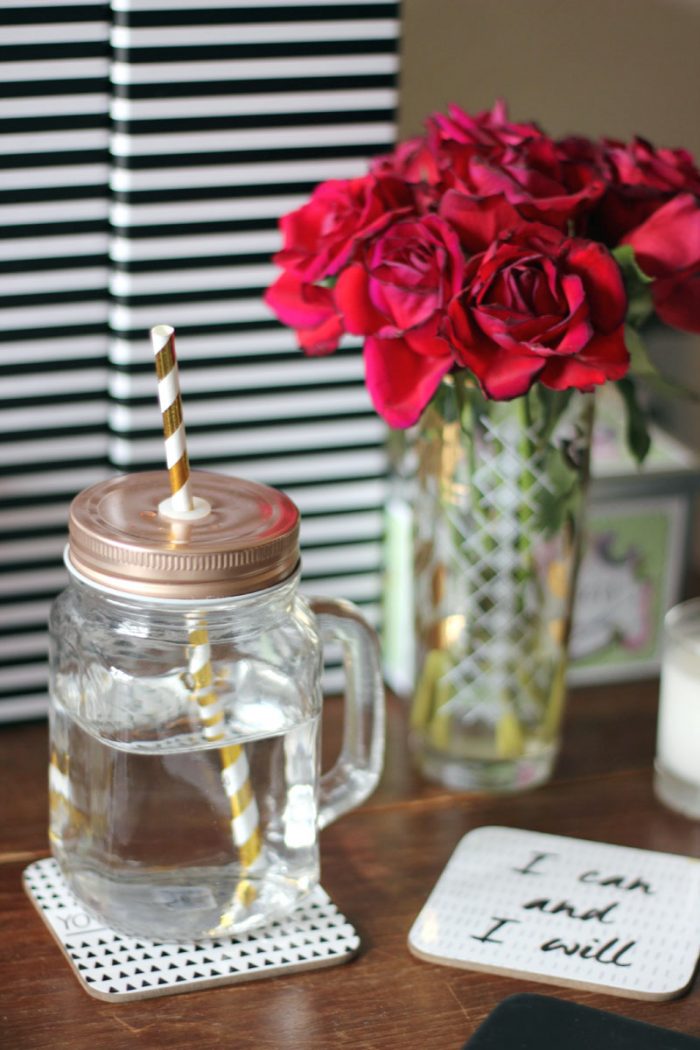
[0,0,399,720]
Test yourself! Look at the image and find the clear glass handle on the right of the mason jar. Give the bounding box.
[307,597,384,828]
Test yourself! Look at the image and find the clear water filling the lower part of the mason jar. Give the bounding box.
[49,679,319,941]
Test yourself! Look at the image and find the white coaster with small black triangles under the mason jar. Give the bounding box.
[24,859,360,1002]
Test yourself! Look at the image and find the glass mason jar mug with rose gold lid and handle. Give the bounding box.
[49,473,384,940]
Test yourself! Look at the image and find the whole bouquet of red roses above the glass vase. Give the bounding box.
[266,102,700,453]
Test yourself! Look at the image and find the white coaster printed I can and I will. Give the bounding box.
[408,827,700,1000]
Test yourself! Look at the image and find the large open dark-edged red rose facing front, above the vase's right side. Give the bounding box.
[449,224,629,400]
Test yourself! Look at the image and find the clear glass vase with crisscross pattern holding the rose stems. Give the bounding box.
[410,373,593,791]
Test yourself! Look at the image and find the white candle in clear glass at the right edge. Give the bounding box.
[656,599,700,817]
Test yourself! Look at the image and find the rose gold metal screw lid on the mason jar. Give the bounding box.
[68,470,299,599]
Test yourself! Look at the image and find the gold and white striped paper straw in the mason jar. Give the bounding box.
[151,324,261,927]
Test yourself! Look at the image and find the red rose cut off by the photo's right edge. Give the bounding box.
[624,193,700,332]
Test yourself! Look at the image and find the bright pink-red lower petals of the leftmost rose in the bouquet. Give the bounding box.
[264,273,343,354]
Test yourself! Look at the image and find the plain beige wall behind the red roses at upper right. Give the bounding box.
[401,0,700,564]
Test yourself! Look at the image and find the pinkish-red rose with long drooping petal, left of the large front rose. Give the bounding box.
[335,215,464,426]
